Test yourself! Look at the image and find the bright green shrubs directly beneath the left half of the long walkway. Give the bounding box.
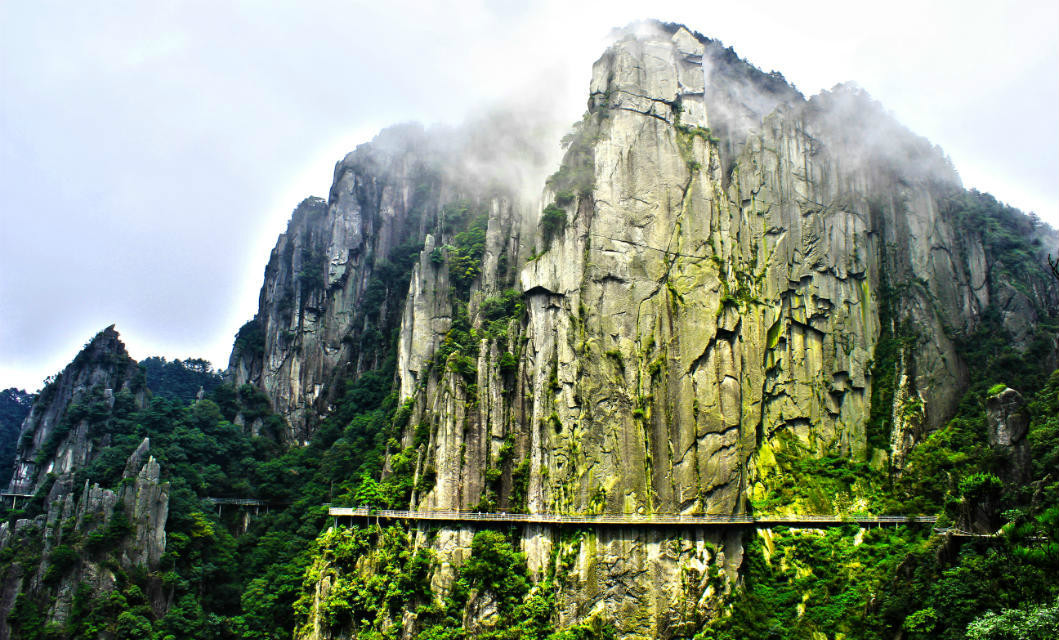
[294,526,614,640]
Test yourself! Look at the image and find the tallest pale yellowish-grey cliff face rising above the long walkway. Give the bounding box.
[402,29,1057,523]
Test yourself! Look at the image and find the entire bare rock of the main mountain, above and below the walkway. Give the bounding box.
[242,25,1059,637]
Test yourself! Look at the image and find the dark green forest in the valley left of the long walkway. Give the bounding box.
[0,362,395,638]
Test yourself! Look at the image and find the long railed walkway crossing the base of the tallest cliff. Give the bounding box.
[327,506,937,527]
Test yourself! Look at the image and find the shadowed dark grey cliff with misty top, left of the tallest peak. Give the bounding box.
[229,118,543,442]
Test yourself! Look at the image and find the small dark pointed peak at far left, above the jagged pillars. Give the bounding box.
[10,325,147,494]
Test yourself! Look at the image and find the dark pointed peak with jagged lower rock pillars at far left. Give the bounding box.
[0,326,169,640]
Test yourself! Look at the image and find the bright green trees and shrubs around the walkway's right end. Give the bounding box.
[698,373,1059,640]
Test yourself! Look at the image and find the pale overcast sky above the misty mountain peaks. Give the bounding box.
[0,0,1059,391]
